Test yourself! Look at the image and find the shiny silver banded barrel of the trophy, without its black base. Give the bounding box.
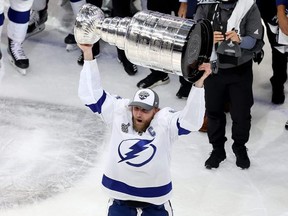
[124,11,195,76]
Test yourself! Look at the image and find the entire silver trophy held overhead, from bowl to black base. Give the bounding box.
[74,4,213,83]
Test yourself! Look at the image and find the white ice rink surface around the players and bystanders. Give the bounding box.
[0,1,288,216]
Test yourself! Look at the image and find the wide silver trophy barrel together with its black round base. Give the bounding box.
[124,11,213,82]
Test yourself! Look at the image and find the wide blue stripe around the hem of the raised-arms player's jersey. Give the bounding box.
[102,175,172,198]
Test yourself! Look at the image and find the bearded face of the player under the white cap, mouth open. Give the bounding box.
[132,106,159,132]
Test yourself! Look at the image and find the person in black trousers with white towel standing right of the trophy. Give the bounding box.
[195,0,263,169]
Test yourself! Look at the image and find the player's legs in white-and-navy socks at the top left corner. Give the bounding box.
[0,0,33,75]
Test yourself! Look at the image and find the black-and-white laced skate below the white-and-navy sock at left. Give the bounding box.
[7,38,29,75]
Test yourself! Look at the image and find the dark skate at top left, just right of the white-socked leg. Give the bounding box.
[26,9,48,38]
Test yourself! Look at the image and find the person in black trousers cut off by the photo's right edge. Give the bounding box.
[257,0,288,104]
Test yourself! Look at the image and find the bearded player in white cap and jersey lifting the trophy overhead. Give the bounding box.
[78,45,211,216]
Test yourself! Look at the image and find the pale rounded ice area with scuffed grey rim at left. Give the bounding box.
[0,98,104,209]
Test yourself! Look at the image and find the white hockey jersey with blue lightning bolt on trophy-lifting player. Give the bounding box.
[78,60,205,205]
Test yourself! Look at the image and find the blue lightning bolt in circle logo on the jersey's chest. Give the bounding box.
[118,139,157,167]
